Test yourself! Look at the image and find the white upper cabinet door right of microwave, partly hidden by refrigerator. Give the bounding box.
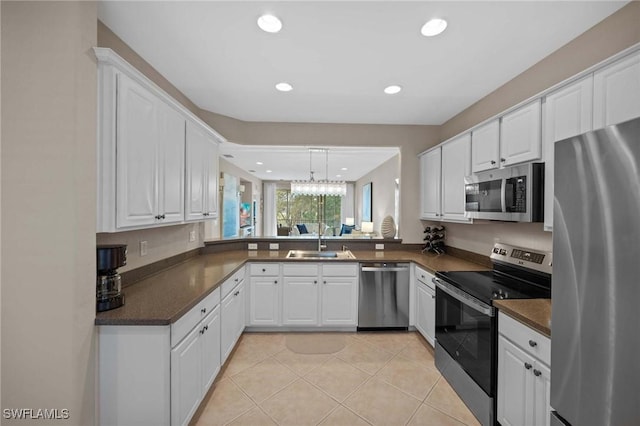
[543,75,593,231]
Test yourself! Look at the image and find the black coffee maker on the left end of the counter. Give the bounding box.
[96,244,127,312]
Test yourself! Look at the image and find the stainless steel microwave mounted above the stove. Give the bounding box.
[464,163,544,222]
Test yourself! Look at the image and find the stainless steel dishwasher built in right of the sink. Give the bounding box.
[358,262,409,331]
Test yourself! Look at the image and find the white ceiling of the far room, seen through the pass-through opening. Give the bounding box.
[220,143,400,181]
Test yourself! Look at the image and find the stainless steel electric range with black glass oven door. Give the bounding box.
[433,243,551,425]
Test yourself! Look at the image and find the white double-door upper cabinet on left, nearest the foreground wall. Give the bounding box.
[106,73,185,231]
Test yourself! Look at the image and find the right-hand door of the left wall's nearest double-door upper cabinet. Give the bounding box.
[157,102,185,223]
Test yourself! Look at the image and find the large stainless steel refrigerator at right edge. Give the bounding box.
[551,115,640,426]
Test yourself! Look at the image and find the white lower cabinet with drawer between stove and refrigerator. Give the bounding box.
[497,312,551,426]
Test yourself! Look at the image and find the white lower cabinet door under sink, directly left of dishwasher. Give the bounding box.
[321,277,358,326]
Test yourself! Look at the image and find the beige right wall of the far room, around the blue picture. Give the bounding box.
[355,154,400,235]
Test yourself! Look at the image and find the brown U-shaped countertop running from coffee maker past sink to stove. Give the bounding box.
[95,250,488,325]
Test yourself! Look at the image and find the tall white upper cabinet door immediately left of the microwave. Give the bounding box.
[441,133,471,222]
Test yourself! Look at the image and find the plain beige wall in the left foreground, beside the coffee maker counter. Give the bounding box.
[1,1,97,425]
